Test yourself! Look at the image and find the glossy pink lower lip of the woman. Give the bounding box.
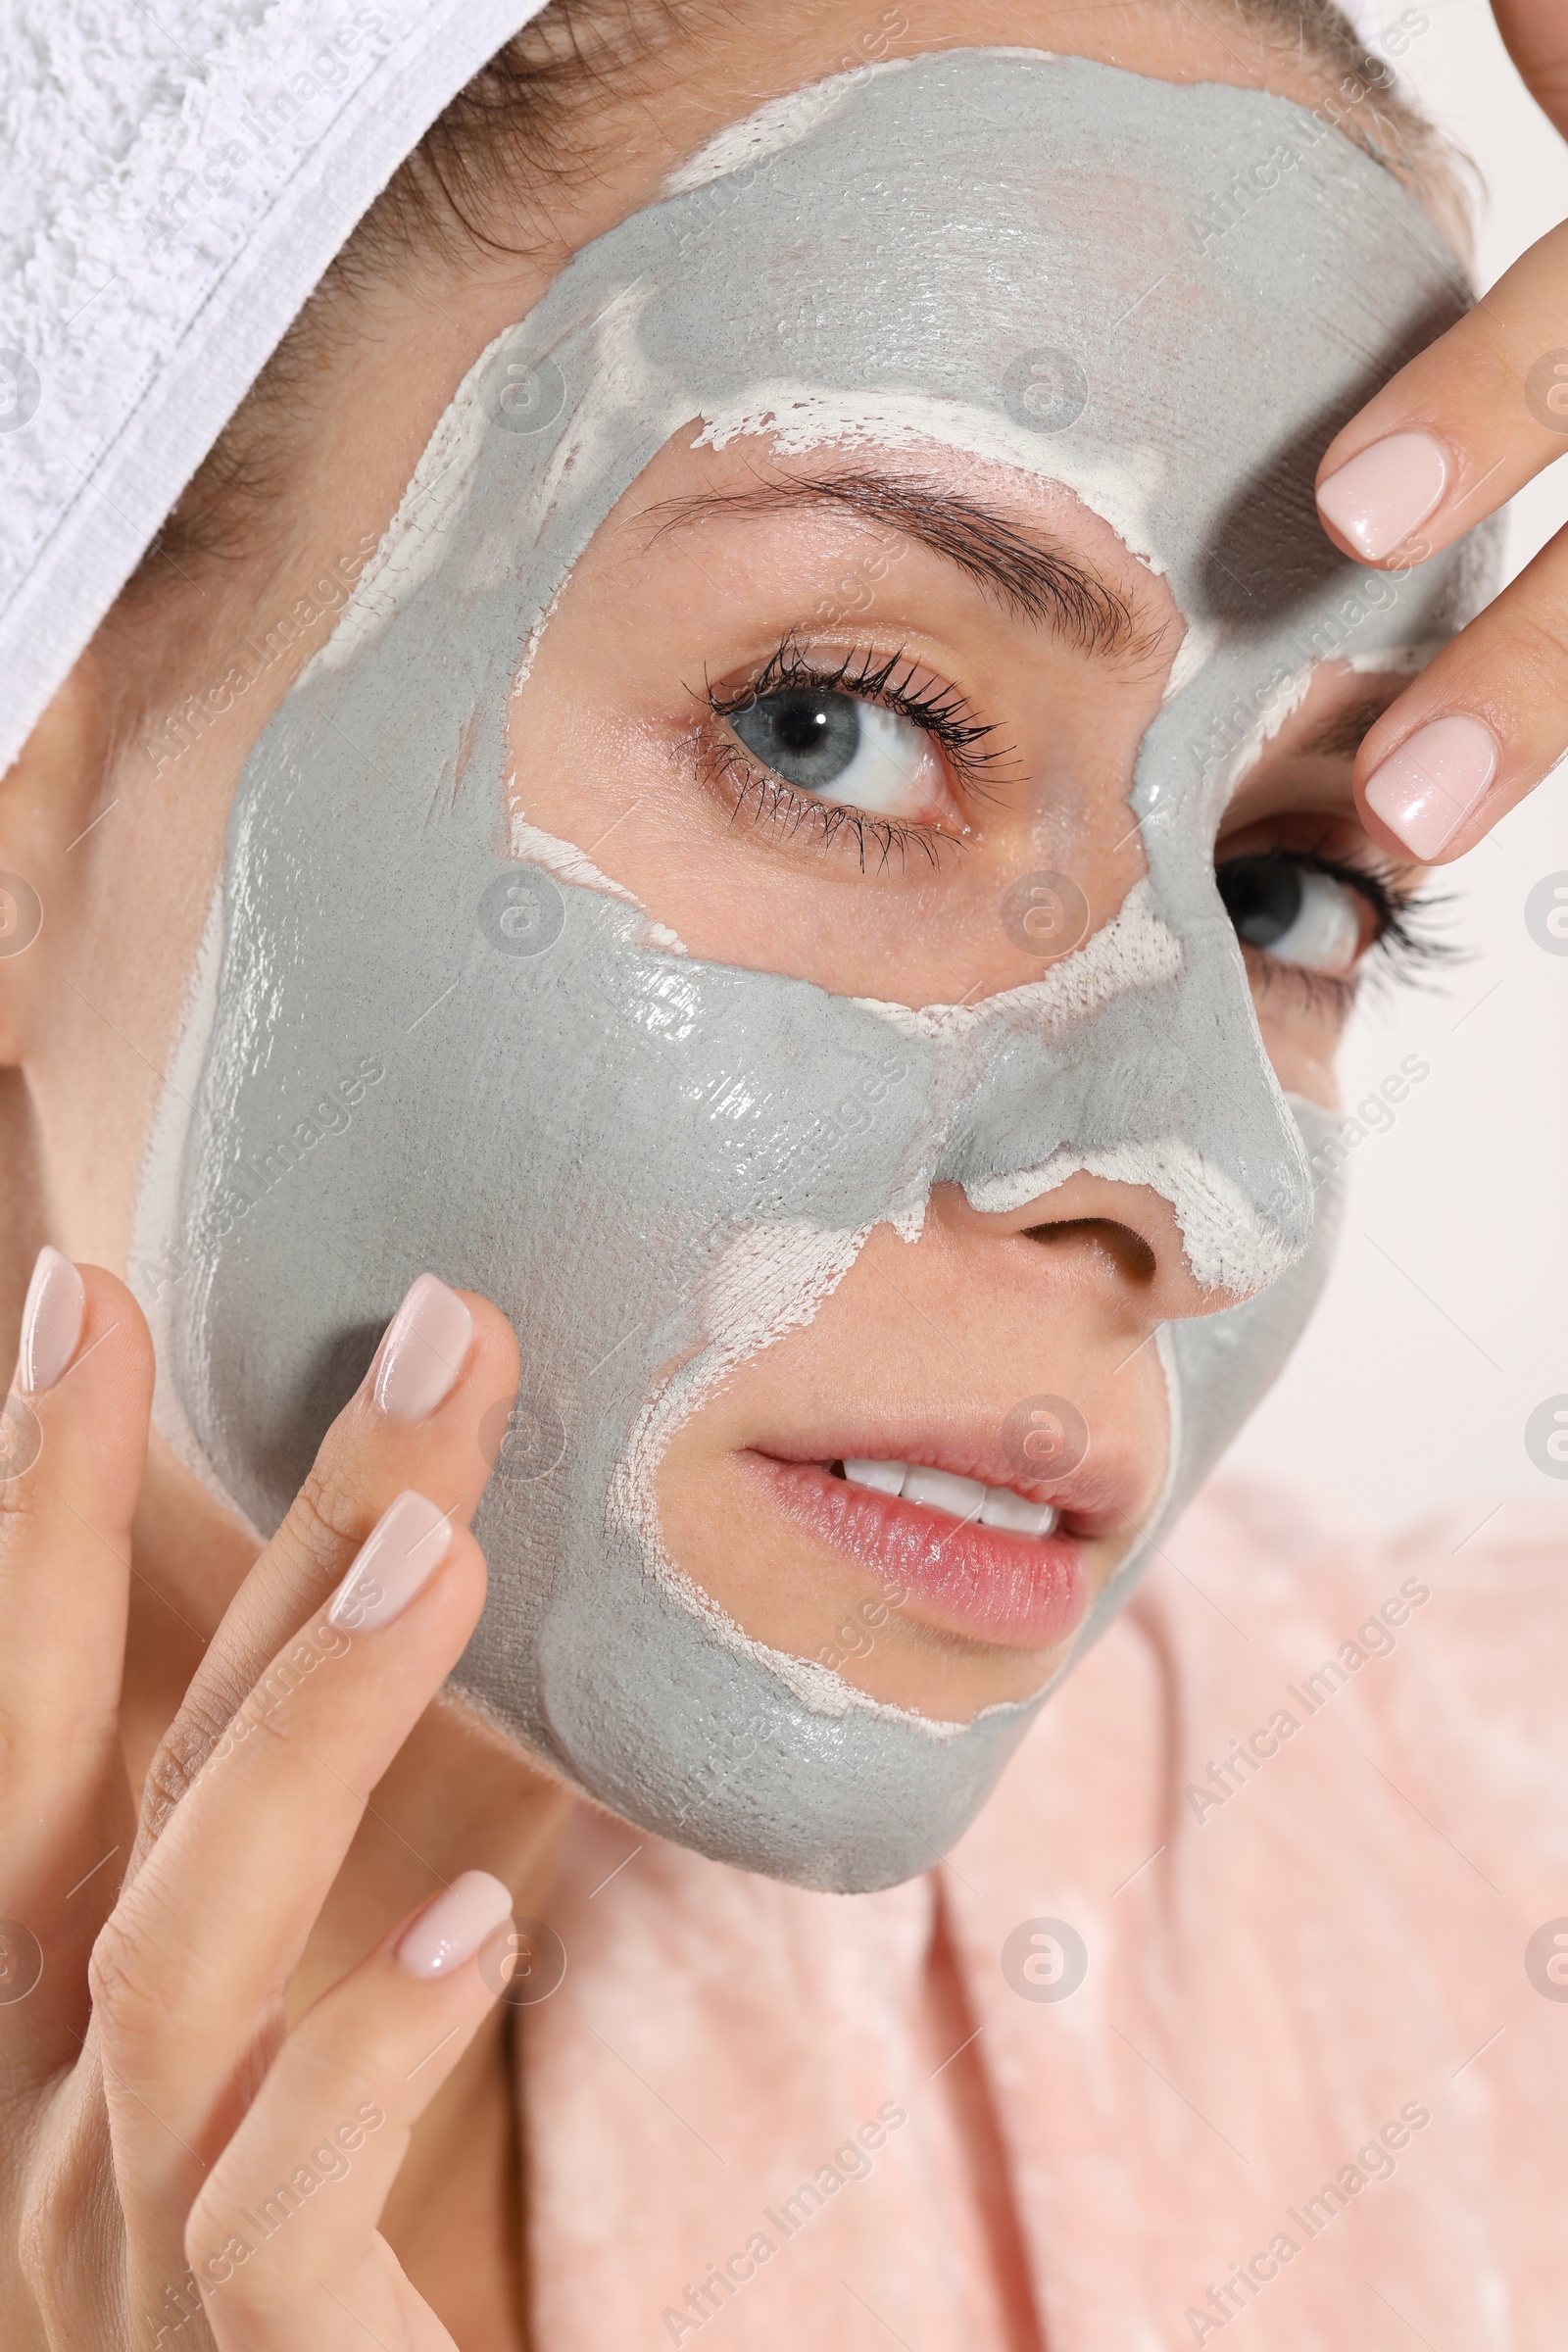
[738,1451,1089,1648]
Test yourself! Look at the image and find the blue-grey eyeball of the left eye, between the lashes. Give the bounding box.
[729,684,948,818]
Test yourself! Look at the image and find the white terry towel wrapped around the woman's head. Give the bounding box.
[0,0,543,774]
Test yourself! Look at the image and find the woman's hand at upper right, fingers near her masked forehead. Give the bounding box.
[1316,0,1568,865]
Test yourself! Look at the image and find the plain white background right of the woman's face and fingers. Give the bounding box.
[1227,0,1568,1531]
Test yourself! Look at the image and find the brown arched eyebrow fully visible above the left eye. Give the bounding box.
[647,470,1148,654]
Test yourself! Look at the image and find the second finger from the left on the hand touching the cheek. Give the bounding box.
[136,1275,517,1863]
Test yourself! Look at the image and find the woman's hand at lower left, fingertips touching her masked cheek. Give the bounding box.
[0,1251,517,2352]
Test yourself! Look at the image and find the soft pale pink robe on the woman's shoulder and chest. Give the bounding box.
[522,1484,1568,2352]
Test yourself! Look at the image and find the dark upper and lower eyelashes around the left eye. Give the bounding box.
[701,635,1006,872]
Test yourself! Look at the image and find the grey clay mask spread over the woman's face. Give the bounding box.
[136,52,1472,1891]
